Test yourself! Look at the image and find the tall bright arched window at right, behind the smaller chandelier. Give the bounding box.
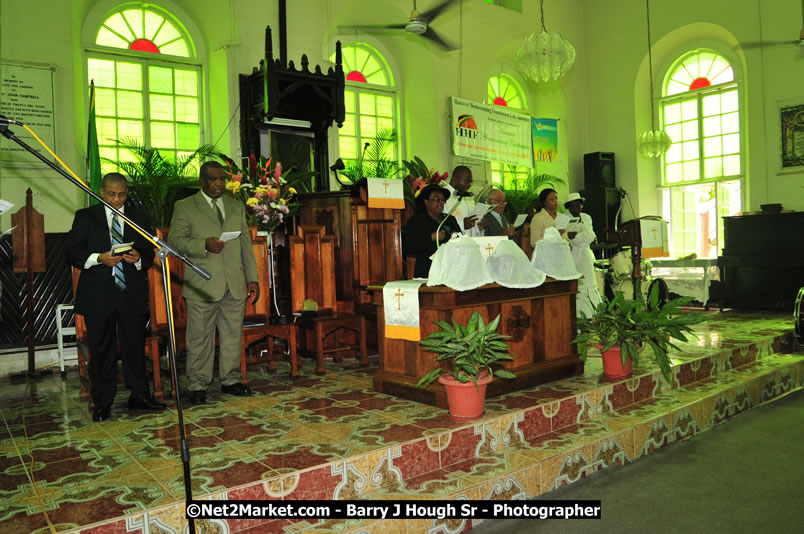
[660,49,743,258]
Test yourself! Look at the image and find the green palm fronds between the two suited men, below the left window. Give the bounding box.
[103,138,220,228]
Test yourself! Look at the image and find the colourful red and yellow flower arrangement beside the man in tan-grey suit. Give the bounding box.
[223,154,299,233]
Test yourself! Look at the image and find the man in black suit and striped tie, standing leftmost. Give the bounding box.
[67,173,165,422]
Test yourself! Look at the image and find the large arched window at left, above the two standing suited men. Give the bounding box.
[87,4,202,166]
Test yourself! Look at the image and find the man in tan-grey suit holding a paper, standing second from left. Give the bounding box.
[168,161,260,404]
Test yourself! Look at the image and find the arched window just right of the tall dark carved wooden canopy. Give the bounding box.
[330,43,399,168]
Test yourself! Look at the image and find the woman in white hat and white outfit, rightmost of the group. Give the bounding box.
[564,193,600,317]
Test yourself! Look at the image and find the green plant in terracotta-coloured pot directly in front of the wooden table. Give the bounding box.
[416,310,516,421]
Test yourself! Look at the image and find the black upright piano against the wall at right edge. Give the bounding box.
[718,212,804,310]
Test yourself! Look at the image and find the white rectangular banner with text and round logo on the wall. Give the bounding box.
[452,97,533,167]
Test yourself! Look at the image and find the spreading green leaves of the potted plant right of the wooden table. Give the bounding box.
[573,284,707,381]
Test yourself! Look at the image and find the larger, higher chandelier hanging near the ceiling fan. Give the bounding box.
[514,0,575,82]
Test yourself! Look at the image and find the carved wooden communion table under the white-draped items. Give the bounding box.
[368,278,583,408]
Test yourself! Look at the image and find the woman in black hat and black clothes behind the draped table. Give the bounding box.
[405,184,461,278]
